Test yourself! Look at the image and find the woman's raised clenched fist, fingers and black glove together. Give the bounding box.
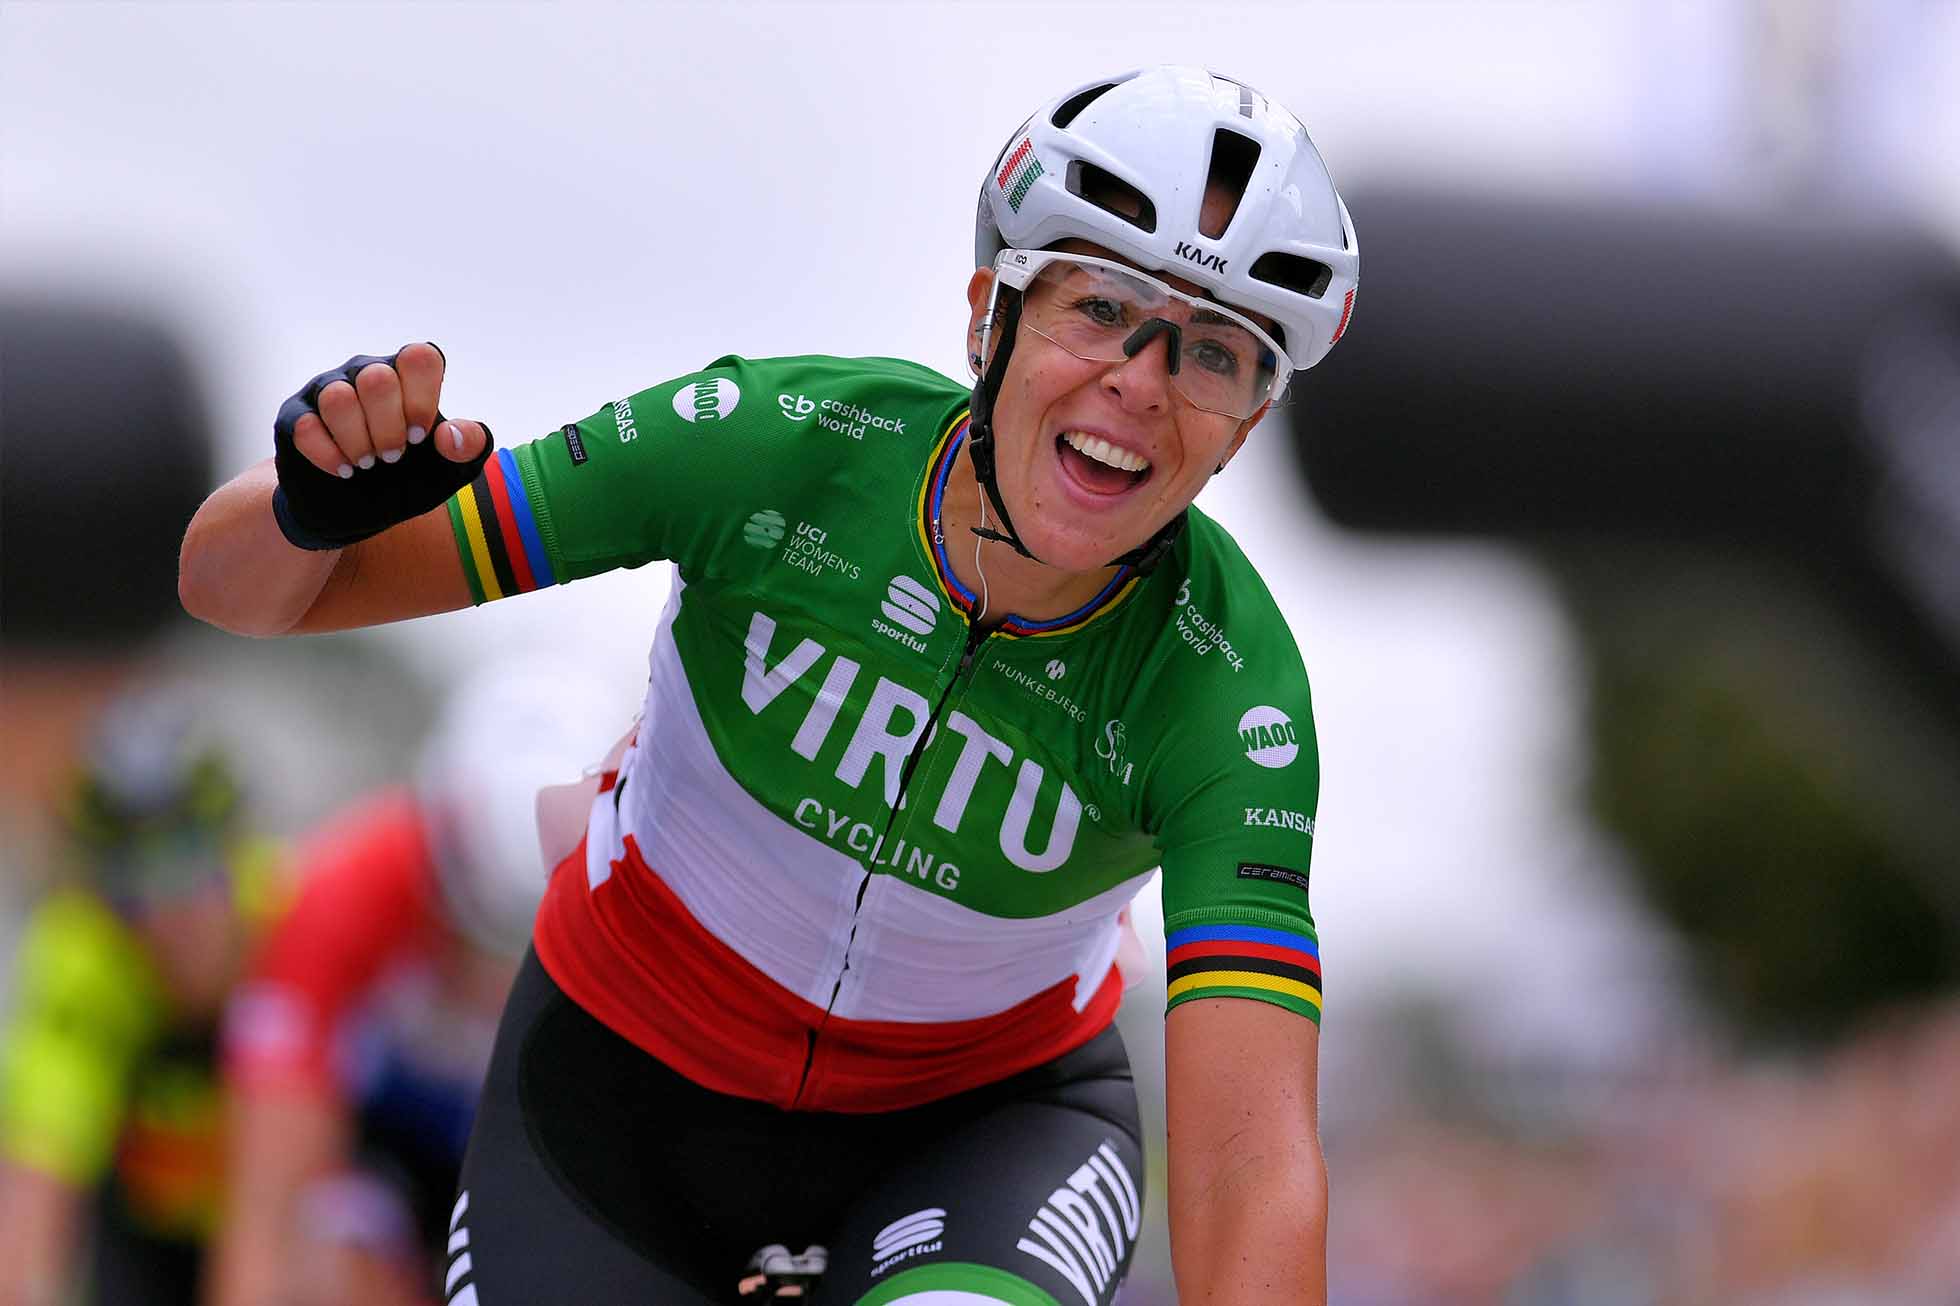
[272,343,492,549]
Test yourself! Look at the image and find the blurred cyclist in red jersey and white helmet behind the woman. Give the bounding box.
[208,665,631,1306]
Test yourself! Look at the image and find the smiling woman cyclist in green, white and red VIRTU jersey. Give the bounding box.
[180,67,1358,1306]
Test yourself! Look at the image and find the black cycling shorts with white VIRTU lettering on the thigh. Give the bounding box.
[441,955,1143,1306]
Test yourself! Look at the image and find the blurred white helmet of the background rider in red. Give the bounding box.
[416,661,633,955]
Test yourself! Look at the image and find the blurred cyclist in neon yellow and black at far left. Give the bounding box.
[0,690,278,1306]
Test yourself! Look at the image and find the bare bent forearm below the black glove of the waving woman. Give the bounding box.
[176,459,341,635]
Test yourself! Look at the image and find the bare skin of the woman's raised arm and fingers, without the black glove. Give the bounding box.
[176,345,488,635]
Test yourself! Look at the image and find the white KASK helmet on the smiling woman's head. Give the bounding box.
[974,65,1360,371]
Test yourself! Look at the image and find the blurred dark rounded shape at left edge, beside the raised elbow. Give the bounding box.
[0,298,214,655]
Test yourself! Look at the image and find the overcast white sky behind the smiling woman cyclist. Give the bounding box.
[0,0,1960,1051]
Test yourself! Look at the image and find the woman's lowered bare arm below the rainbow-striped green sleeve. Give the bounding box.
[1164,998,1327,1306]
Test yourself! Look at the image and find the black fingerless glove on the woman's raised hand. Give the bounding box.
[272,353,496,549]
